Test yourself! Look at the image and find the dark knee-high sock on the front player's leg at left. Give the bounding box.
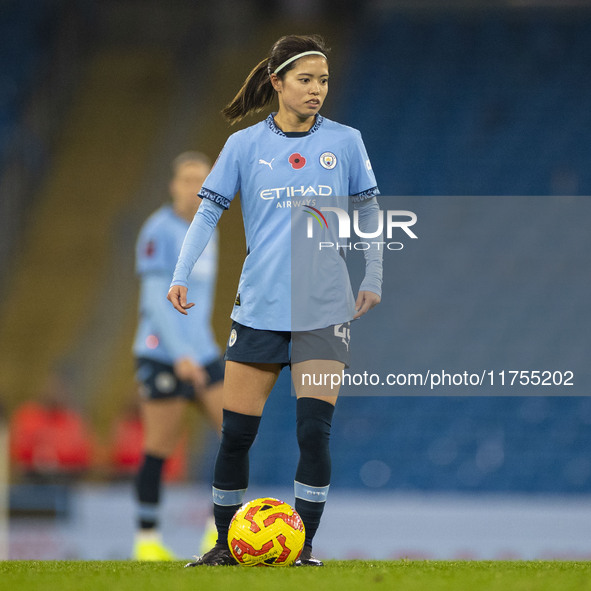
[213,409,261,544]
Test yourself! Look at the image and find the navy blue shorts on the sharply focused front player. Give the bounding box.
[224,320,351,367]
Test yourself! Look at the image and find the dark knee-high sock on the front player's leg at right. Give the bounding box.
[294,398,334,546]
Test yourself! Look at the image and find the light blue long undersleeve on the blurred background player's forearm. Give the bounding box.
[141,273,198,361]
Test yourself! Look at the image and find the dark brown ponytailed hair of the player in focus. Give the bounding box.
[222,35,330,124]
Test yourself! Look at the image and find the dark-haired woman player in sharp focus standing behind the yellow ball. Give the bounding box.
[168,35,382,566]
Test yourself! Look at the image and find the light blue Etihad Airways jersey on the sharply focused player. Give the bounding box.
[199,114,379,331]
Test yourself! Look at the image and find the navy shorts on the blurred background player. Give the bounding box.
[135,357,224,400]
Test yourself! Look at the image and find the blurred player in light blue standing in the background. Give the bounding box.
[133,152,224,560]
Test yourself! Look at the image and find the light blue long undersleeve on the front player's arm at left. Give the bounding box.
[170,199,224,287]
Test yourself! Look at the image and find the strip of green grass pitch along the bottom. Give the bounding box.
[0,560,591,591]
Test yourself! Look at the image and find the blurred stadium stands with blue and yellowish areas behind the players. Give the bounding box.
[0,0,591,557]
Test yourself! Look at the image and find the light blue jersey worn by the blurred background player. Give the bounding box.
[133,205,220,365]
